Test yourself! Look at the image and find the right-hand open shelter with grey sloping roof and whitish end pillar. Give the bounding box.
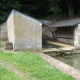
[50,18,80,48]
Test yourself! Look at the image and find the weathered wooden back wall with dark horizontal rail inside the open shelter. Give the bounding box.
[57,27,74,44]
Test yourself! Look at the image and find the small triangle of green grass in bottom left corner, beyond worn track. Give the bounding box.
[0,66,21,80]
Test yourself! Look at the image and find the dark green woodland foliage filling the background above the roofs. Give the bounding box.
[0,0,80,23]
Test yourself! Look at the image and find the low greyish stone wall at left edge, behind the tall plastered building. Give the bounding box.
[0,22,7,40]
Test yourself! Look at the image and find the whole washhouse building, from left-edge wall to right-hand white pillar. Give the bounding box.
[0,10,80,51]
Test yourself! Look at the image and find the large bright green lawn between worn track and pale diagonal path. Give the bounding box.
[0,50,75,80]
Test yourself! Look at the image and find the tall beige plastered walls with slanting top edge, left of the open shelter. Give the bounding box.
[7,10,42,51]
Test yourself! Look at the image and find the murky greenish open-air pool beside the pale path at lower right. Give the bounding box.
[52,54,80,70]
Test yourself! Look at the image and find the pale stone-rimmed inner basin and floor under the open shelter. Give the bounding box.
[43,41,75,53]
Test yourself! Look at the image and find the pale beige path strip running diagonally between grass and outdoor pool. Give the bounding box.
[39,53,80,80]
